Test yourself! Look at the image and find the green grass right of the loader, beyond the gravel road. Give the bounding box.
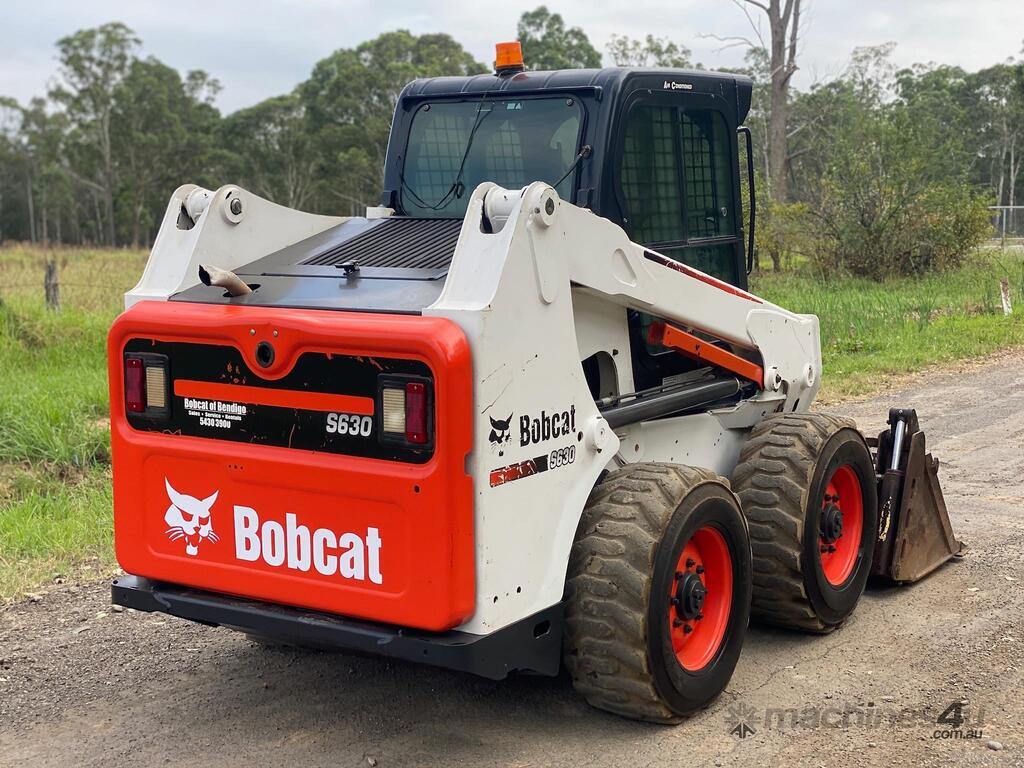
[751,249,1024,401]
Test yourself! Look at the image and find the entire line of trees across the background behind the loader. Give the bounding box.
[0,6,1024,276]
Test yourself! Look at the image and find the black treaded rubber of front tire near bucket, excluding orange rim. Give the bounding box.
[732,413,878,633]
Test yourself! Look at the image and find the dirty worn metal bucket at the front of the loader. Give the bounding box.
[869,408,966,584]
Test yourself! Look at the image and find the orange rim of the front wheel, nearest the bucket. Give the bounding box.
[818,464,864,587]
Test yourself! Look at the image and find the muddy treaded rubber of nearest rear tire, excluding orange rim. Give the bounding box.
[565,463,751,724]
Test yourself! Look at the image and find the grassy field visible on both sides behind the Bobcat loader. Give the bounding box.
[0,243,1024,600]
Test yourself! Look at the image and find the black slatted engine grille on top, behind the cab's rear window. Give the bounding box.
[302,217,462,269]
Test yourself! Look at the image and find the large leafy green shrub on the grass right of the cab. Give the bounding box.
[807,80,991,280]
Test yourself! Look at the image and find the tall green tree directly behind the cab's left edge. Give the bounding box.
[298,30,487,213]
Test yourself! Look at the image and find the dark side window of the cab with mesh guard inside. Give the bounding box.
[618,101,742,285]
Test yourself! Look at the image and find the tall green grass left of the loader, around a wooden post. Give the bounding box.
[0,248,145,600]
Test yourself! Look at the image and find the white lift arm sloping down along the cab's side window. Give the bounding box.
[442,182,821,411]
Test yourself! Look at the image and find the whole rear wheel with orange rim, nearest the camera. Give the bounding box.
[565,463,751,723]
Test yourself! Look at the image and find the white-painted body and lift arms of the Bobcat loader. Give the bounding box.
[125,182,821,635]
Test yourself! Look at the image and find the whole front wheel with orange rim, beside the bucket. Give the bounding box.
[732,414,879,632]
